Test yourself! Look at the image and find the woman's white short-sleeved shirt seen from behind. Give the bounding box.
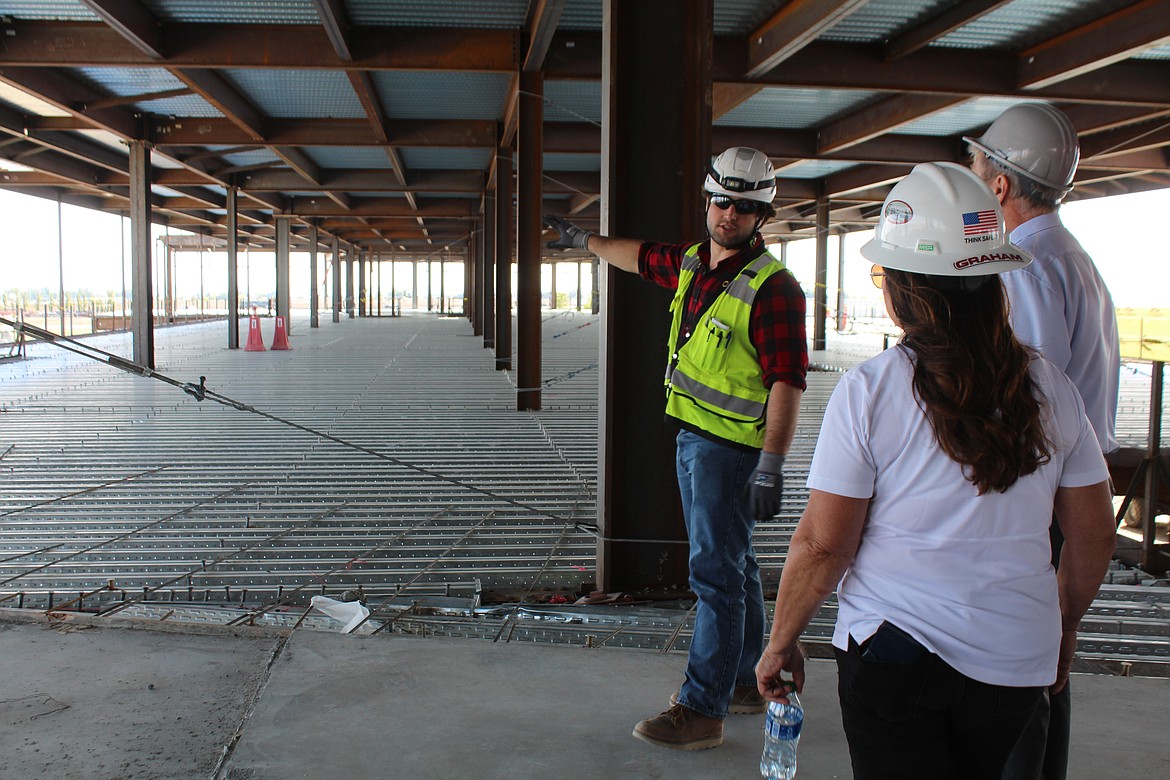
[808,347,1108,686]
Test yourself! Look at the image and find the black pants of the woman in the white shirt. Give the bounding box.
[835,623,1044,780]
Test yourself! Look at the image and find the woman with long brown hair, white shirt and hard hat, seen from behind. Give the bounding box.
[756,163,1114,780]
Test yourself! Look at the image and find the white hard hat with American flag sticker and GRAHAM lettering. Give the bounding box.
[861,163,1032,276]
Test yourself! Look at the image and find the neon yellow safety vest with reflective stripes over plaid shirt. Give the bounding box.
[666,244,784,447]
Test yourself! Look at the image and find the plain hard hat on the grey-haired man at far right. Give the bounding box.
[963,103,1081,192]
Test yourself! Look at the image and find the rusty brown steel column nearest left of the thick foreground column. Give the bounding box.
[516,70,542,412]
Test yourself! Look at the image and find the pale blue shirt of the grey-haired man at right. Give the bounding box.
[999,213,1121,453]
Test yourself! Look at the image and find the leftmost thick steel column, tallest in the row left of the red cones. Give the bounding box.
[128,140,154,368]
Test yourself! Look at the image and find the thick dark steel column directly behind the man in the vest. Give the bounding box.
[598,0,714,591]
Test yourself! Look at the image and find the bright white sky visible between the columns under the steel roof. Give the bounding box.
[0,189,1170,309]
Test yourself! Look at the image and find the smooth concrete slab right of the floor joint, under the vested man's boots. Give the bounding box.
[227,633,849,780]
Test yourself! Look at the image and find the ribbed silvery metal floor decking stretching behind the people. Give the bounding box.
[0,312,1170,664]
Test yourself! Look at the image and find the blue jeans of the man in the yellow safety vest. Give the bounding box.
[676,430,764,718]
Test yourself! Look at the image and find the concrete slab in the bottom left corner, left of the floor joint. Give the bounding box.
[0,621,280,780]
